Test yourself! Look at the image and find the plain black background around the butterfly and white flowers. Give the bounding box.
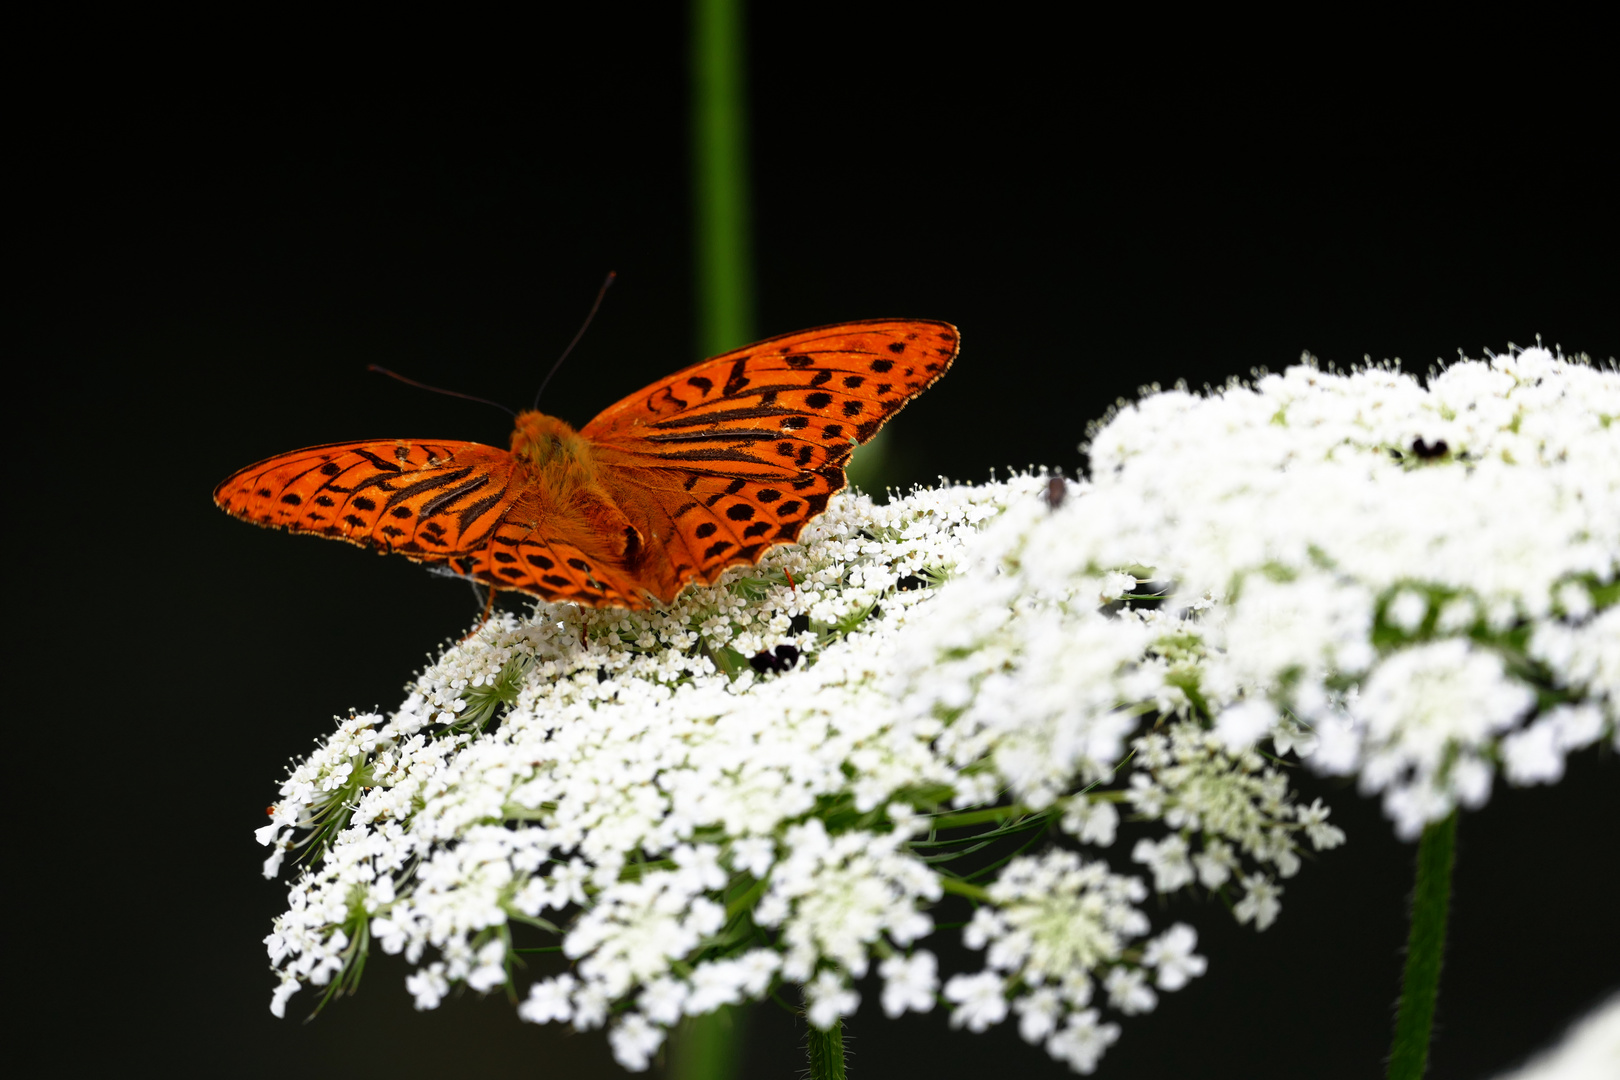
[6,5,1620,1078]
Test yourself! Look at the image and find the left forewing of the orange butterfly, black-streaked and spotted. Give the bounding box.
[214,439,518,562]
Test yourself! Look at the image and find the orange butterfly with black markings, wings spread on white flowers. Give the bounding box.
[214,319,959,609]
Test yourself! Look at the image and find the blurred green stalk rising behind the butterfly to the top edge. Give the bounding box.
[692,0,753,356]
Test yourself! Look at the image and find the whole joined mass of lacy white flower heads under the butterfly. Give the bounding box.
[259,350,1620,1072]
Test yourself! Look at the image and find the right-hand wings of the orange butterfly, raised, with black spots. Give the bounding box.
[580,319,959,605]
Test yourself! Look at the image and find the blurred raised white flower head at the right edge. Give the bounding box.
[1101,348,1620,837]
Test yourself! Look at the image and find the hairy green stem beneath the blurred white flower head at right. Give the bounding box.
[1388,810,1456,1080]
